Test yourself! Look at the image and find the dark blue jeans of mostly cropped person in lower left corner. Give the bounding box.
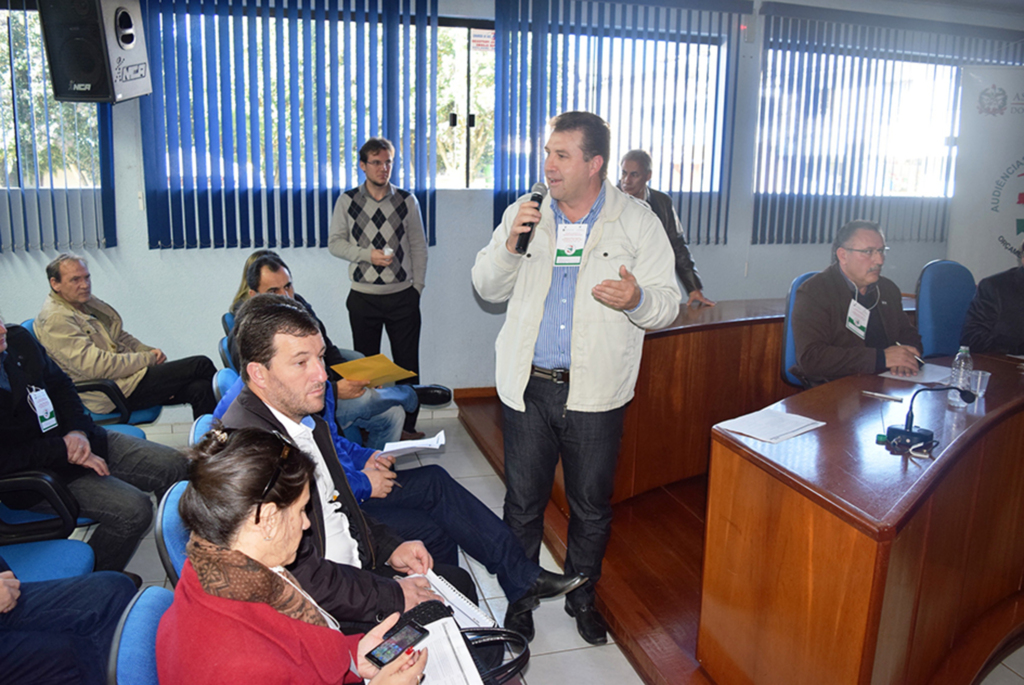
[0,572,135,685]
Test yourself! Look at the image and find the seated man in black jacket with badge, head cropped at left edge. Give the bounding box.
[0,322,186,570]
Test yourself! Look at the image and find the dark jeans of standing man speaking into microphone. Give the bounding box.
[502,378,626,606]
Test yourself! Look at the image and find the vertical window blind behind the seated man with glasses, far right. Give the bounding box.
[753,2,1024,244]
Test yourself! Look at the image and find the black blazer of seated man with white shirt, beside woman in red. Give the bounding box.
[222,387,406,623]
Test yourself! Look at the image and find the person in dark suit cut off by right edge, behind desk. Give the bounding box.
[961,237,1024,354]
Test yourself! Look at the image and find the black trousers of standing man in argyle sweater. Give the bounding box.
[346,288,421,432]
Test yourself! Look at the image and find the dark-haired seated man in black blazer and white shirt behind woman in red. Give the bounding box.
[223,295,468,628]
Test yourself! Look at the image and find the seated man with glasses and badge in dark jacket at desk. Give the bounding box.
[791,220,921,387]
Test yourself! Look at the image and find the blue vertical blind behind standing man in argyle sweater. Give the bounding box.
[141,0,437,249]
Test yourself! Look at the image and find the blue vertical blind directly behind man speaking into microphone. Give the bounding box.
[495,0,753,244]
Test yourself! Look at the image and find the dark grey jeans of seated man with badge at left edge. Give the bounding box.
[68,431,188,570]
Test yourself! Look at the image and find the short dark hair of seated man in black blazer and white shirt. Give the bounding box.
[234,293,319,383]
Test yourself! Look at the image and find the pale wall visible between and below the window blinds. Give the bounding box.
[0,0,1024,421]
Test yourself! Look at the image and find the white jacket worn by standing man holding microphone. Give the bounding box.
[473,181,682,412]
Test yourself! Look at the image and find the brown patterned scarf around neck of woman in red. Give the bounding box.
[185,533,328,628]
